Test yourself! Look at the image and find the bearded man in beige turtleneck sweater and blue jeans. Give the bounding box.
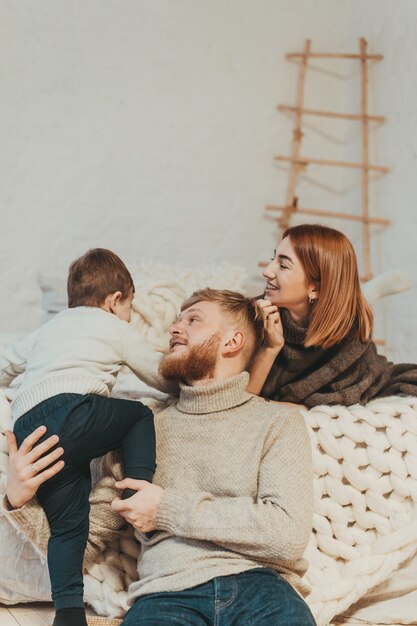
[4,289,315,626]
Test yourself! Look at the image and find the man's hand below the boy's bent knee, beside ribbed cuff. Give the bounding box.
[111,478,163,533]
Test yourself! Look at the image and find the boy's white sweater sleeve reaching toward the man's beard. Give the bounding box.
[120,325,179,395]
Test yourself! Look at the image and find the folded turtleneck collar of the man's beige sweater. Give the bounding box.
[177,372,252,414]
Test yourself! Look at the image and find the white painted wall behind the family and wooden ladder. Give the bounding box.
[0,0,417,360]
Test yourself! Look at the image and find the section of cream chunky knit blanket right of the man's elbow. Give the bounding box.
[302,396,417,626]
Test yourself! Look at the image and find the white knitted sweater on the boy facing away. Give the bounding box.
[0,306,175,420]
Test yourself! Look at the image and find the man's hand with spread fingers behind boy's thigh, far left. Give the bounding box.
[5,426,64,509]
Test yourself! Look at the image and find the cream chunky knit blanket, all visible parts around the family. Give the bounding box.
[0,266,417,626]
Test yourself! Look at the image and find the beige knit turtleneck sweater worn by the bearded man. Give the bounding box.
[129,373,313,602]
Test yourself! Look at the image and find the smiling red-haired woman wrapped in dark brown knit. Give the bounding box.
[248,224,417,407]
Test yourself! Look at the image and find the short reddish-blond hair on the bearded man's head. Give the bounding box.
[181,287,264,368]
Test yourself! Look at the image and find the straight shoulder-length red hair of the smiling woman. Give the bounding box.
[283,224,373,348]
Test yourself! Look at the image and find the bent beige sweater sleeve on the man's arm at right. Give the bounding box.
[156,411,313,563]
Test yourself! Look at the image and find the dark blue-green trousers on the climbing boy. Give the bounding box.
[14,393,156,609]
